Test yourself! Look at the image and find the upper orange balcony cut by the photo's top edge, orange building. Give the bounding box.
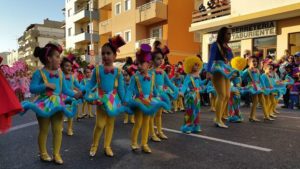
[136,0,168,25]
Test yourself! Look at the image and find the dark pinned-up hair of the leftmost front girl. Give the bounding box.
[33,43,62,65]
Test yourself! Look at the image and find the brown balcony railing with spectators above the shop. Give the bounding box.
[192,4,231,23]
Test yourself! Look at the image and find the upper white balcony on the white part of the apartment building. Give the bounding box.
[73,9,99,23]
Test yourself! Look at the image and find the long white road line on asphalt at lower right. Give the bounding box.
[163,128,272,152]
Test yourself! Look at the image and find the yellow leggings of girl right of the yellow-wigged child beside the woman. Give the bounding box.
[250,94,269,119]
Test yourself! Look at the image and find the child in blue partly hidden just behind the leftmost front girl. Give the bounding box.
[60,57,84,136]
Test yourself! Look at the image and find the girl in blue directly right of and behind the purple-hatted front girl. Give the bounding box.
[150,49,178,142]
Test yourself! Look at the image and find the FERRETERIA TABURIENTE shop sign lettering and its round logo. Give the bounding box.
[209,21,276,43]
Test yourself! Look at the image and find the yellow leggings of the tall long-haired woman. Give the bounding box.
[212,73,230,124]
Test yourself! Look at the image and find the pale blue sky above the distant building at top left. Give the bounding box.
[0,0,65,52]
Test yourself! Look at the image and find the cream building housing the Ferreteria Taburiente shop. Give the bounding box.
[189,0,300,61]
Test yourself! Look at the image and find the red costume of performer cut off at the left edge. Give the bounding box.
[0,56,22,134]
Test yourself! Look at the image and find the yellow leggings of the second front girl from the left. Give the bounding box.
[92,106,115,148]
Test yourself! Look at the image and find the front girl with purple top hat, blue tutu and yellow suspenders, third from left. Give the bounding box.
[125,44,170,153]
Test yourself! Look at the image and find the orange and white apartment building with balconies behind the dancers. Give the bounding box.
[66,0,200,63]
